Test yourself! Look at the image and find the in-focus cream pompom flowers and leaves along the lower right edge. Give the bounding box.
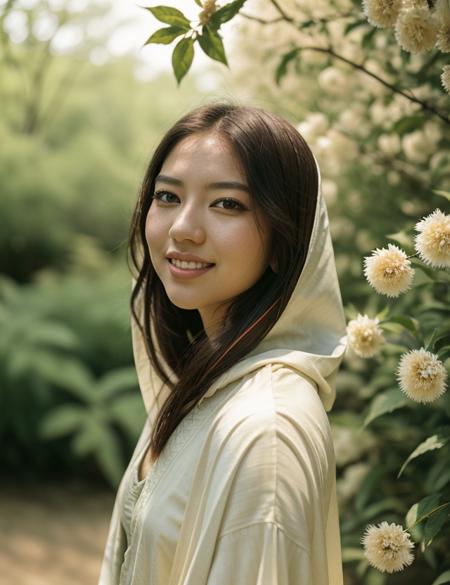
[347,198,450,573]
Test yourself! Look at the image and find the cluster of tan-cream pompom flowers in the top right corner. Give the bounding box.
[362,0,450,93]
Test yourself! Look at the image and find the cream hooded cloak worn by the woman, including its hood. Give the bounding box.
[99,154,346,585]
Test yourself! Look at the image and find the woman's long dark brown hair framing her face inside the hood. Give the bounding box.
[129,103,318,460]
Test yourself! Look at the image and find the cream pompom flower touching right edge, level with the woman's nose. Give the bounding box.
[414,209,450,268]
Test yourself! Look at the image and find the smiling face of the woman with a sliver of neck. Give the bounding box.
[146,132,270,337]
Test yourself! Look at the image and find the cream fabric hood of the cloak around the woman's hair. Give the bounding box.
[131,157,347,420]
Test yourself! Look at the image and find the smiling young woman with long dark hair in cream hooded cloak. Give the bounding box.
[99,103,346,585]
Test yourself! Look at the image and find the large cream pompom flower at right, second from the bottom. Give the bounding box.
[397,347,447,403]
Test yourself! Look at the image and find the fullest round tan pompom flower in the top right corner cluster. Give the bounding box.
[395,6,438,53]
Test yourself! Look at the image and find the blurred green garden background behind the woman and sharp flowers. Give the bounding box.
[0,0,450,585]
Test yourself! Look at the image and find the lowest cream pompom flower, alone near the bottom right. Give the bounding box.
[361,522,414,573]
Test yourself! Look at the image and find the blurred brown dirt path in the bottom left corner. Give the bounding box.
[0,483,114,585]
